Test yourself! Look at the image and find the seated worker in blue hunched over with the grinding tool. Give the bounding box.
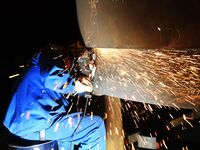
[3,45,106,150]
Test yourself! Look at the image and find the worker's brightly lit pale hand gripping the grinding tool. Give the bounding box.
[74,77,93,94]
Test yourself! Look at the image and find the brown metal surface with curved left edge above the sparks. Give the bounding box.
[76,0,200,48]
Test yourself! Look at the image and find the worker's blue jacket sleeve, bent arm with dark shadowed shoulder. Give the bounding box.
[35,51,75,94]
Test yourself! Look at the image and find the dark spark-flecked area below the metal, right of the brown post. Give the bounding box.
[122,100,200,150]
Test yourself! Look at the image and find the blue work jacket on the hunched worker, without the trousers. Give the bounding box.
[3,50,74,137]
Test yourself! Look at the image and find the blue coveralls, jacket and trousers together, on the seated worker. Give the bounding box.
[3,51,106,150]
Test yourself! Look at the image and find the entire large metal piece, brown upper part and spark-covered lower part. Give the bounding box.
[76,0,200,109]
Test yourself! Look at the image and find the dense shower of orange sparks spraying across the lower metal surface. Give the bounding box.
[94,48,200,111]
